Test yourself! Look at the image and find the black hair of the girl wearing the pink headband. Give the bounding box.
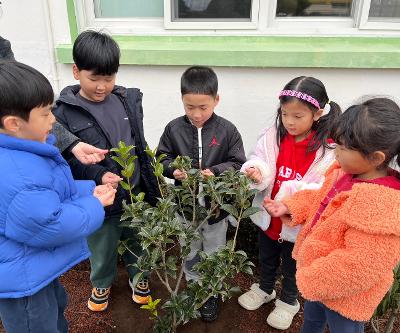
[275,76,342,156]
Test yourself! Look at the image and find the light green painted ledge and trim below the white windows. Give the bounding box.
[57,0,400,69]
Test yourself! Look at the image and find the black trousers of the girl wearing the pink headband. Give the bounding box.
[259,230,298,305]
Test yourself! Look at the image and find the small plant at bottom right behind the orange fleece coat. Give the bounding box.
[371,264,400,333]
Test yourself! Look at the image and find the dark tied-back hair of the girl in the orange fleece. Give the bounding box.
[333,98,400,167]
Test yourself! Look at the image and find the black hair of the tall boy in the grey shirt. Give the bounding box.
[72,30,121,75]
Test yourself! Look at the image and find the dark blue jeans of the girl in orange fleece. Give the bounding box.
[301,301,364,333]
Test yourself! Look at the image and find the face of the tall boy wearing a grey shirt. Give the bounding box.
[72,65,116,102]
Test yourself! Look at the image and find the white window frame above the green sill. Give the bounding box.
[73,0,400,36]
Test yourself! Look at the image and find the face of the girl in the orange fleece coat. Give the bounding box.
[335,144,376,178]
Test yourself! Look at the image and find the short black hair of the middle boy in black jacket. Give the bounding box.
[181,66,218,97]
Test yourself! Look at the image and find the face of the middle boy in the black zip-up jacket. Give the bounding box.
[182,94,219,128]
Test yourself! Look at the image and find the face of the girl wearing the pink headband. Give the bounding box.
[281,99,322,141]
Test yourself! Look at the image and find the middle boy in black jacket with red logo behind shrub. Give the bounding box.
[157,66,246,321]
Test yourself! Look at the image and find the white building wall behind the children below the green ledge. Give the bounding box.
[0,0,400,151]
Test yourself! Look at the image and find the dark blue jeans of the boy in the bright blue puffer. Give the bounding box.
[0,279,68,333]
